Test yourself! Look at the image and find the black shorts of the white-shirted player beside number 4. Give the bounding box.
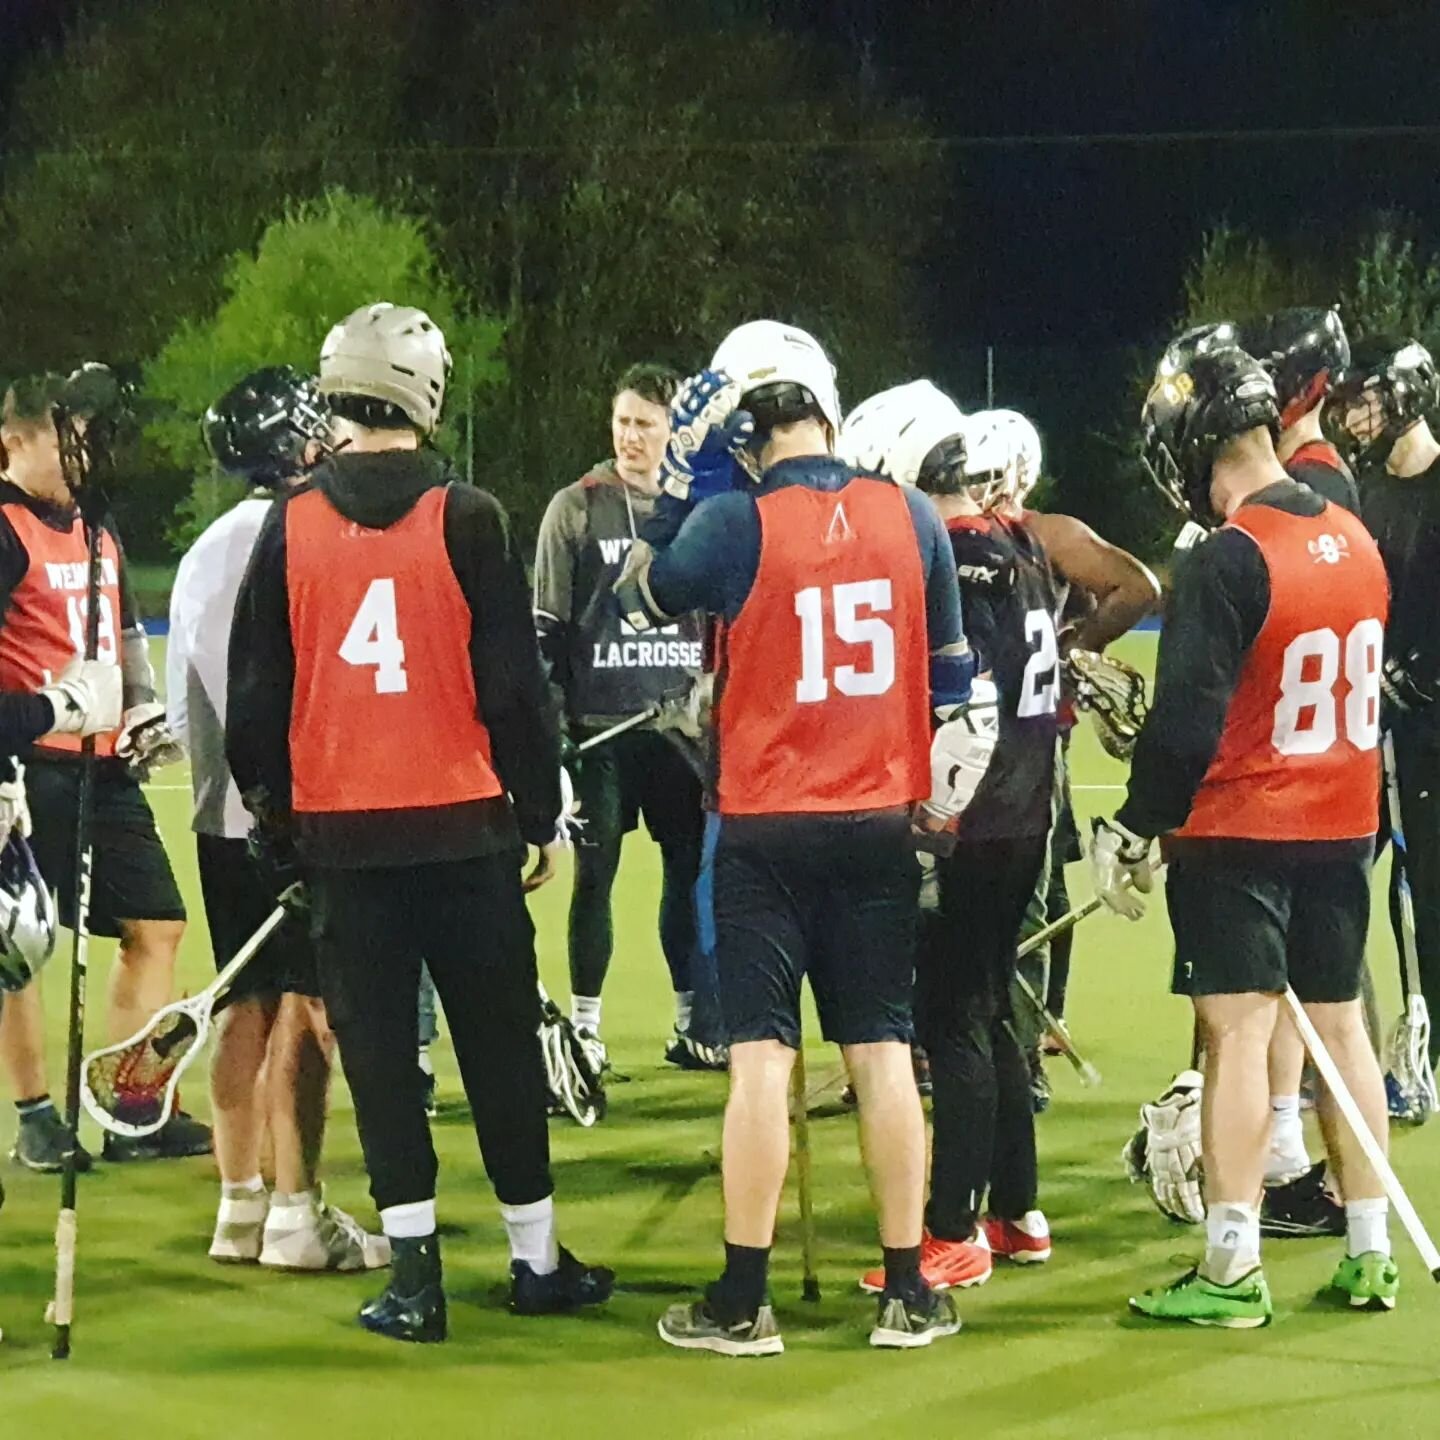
[194,835,320,1001]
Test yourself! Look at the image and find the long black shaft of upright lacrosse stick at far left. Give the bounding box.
[50,501,104,1359]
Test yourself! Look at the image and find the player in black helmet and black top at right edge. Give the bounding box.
[1325,337,1440,1120]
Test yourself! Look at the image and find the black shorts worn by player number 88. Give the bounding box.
[1165,852,1369,1005]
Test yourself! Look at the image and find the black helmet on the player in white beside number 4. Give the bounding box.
[202,364,336,490]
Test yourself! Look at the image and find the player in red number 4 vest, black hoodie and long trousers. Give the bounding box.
[226,304,613,1342]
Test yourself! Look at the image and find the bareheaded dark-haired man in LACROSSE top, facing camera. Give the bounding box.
[534,364,711,1068]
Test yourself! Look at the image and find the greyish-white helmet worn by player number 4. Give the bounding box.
[320,300,451,435]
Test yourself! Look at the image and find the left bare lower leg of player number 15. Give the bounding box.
[721,1040,800,1248]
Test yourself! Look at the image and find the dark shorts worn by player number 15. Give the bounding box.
[707,811,920,1048]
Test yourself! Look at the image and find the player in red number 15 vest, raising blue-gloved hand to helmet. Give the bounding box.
[618,320,991,1355]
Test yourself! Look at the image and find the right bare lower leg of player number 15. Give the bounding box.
[844,1043,924,1250]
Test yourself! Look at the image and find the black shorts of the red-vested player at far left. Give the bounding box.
[24,759,184,937]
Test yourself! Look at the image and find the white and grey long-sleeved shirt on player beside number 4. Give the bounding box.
[166,498,271,840]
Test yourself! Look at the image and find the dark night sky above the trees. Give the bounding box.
[8,0,1440,344]
